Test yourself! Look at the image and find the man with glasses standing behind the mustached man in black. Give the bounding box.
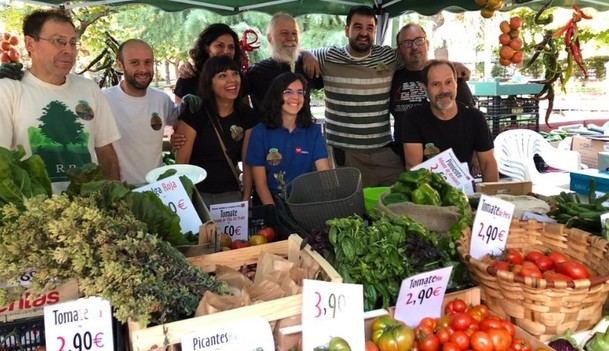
[390,23,474,158]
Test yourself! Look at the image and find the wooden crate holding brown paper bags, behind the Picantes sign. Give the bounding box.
[129,234,342,351]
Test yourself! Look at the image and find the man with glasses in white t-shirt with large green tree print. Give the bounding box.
[0,10,120,193]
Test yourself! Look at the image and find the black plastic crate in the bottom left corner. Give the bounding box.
[0,316,45,351]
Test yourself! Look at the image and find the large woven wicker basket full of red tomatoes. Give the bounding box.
[458,221,609,341]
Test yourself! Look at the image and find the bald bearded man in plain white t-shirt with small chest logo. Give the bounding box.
[103,39,179,185]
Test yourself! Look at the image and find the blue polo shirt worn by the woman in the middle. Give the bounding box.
[246,123,328,194]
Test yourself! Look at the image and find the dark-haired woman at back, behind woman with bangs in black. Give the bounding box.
[173,23,243,103]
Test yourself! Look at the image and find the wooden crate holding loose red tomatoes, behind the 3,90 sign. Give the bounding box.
[275,287,553,351]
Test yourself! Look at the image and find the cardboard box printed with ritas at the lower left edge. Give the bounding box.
[0,270,80,322]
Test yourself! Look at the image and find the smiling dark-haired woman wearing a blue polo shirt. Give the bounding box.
[247,72,330,205]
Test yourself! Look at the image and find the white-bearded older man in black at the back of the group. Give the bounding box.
[245,13,323,109]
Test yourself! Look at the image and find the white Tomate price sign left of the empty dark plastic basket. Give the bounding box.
[209,201,248,240]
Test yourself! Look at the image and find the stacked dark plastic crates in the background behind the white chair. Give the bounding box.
[477,95,539,137]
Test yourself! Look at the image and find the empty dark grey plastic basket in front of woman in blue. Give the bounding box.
[286,167,364,231]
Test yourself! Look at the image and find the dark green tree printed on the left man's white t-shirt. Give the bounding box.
[38,101,84,150]
